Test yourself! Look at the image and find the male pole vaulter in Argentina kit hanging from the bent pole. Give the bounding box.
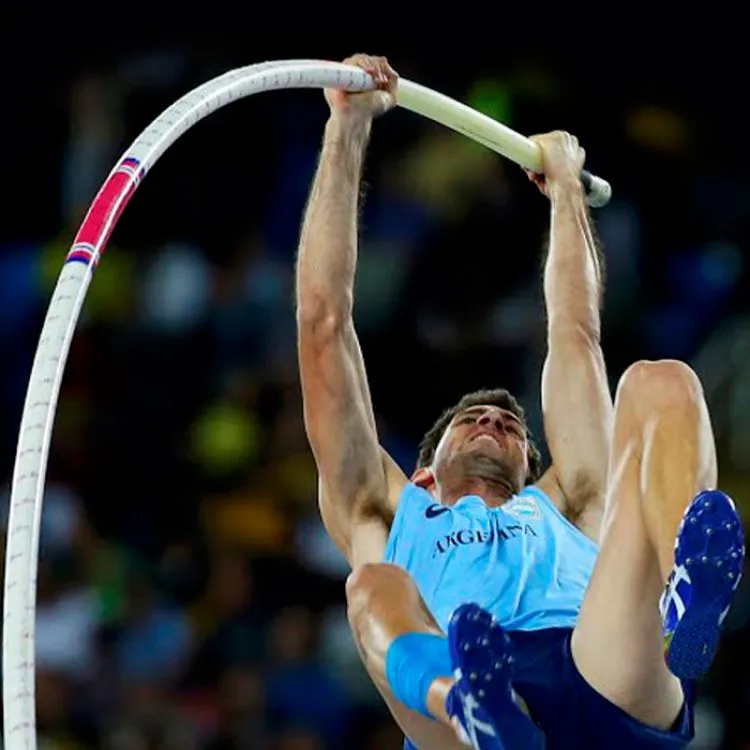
[297,56,744,750]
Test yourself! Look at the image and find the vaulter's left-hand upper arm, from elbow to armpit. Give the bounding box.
[298,318,406,561]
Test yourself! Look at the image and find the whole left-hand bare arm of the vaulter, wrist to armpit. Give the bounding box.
[297,110,387,528]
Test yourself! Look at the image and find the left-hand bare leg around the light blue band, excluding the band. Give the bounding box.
[346,563,465,750]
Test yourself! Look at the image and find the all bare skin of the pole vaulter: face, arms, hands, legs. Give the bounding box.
[296,55,713,748]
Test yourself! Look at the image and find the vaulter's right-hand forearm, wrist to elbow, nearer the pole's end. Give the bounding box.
[544,181,603,338]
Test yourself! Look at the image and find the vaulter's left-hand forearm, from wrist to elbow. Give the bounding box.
[297,115,370,320]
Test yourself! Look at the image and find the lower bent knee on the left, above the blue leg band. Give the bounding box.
[346,563,414,633]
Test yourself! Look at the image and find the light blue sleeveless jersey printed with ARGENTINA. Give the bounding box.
[385,484,598,630]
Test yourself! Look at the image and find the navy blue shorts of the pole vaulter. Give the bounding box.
[508,628,695,750]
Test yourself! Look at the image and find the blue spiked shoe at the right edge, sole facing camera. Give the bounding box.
[659,490,745,680]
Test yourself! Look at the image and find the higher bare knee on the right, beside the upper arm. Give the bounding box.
[617,359,703,416]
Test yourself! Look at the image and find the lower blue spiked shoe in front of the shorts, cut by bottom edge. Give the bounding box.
[446,604,545,750]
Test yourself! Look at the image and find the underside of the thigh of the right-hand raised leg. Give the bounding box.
[571,445,684,728]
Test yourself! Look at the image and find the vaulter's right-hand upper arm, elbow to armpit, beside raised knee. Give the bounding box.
[542,320,613,515]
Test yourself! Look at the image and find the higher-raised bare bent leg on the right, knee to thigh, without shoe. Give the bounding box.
[572,360,717,729]
